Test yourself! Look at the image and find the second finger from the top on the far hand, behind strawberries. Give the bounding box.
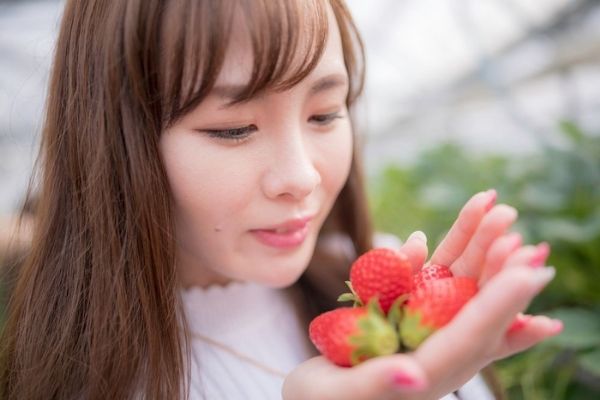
[450,204,517,277]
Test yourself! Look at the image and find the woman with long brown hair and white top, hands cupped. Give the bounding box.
[1,0,557,399]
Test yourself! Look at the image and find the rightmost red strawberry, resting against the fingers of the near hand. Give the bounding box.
[400,276,477,349]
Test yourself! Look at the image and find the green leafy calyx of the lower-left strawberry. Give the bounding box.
[348,299,399,365]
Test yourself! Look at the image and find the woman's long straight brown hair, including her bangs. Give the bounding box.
[0,0,372,400]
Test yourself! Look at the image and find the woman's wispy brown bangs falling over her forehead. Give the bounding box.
[160,0,328,126]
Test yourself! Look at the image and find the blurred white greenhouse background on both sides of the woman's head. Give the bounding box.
[0,0,600,214]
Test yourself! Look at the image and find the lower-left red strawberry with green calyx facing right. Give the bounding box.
[308,302,399,367]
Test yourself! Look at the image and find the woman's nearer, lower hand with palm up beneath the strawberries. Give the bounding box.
[283,265,557,400]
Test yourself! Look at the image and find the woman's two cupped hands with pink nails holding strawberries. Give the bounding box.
[283,191,562,400]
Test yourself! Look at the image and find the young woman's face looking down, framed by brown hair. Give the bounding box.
[160,6,352,287]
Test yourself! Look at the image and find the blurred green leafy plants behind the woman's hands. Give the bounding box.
[369,121,600,400]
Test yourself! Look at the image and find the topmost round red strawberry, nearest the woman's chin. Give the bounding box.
[350,248,412,313]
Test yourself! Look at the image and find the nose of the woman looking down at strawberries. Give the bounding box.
[262,135,321,200]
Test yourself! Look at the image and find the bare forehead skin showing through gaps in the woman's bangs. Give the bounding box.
[216,5,347,85]
